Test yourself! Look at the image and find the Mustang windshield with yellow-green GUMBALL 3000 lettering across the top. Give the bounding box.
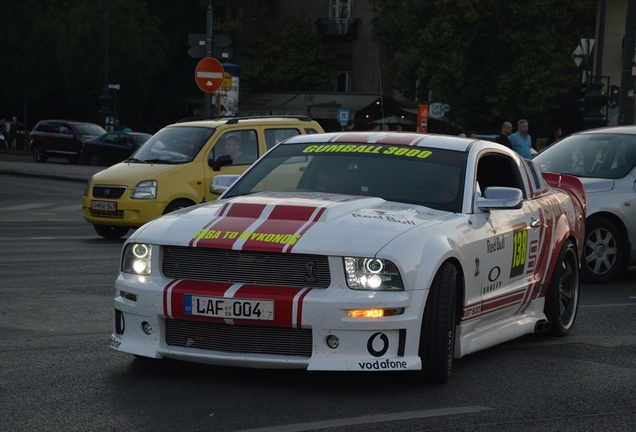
[225,143,466,212]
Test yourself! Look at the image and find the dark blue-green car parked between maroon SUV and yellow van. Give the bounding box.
[80,132,152,166]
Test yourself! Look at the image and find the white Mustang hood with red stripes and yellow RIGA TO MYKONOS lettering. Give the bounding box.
[129,192,453,257]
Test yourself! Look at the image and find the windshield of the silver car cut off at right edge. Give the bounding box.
[533,133,636,179]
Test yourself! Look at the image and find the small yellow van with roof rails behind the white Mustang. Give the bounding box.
[82,117,324,238]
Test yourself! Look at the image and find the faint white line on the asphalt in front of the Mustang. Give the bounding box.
[239,406,494,432]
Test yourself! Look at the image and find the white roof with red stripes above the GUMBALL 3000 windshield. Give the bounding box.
[283,132,476,152]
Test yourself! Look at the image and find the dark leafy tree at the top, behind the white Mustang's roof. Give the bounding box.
[369,0,596,127]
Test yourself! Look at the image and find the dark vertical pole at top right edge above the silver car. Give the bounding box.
[618,0,636,125]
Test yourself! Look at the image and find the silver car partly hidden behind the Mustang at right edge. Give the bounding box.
[533,126,636,283]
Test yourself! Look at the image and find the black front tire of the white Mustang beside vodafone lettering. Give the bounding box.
[419,262,457,384]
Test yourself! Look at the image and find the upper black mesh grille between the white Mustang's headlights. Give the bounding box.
[161,246,331,288]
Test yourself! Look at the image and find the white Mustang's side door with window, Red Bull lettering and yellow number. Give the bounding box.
[474,152,542,326]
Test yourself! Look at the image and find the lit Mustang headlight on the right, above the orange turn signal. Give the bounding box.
[344,257,404,291]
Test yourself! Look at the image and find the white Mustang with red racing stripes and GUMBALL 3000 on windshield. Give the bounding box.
[110,132,585,382]
